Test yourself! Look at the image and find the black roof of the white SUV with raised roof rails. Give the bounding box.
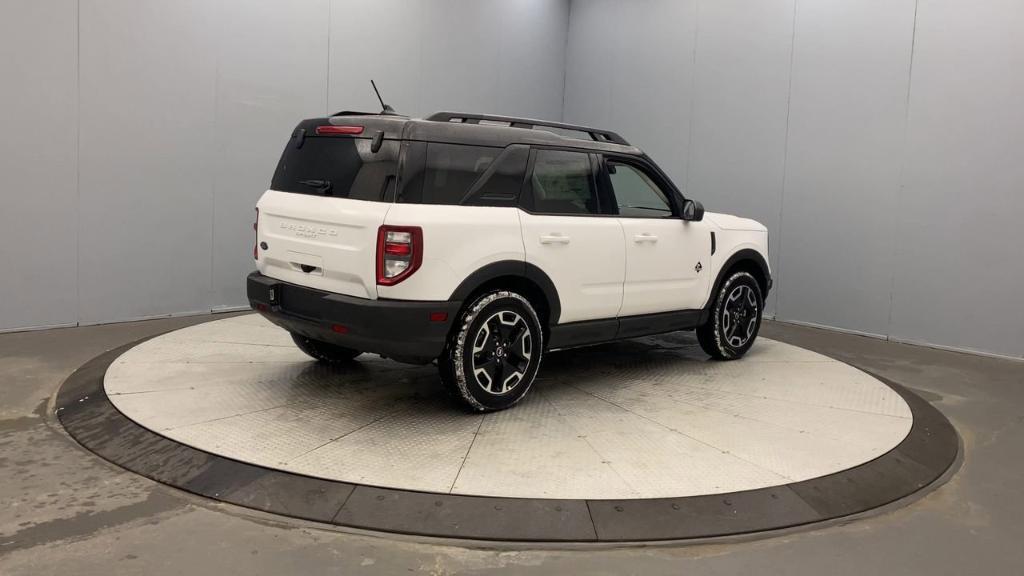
[299,111,641,154]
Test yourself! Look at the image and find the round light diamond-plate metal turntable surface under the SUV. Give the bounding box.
[104,315,912,499]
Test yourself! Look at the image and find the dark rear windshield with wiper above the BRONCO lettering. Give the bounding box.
[270,135,399,201]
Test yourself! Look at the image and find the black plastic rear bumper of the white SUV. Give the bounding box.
[246,272,462,362]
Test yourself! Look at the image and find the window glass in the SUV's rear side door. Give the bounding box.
[526,150,601,214]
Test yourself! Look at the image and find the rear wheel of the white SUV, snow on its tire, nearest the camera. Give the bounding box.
[437,290,544,412]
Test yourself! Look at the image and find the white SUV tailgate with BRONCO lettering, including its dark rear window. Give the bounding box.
[257,123,400,298]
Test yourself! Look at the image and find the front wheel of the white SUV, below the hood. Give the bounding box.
[697,272,764,360]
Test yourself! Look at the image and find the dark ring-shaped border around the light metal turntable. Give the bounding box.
[56,334,959,542]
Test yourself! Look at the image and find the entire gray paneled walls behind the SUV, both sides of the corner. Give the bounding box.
[0,0,1024,358]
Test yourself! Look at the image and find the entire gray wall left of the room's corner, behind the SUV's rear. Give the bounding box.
[0,0,568,330]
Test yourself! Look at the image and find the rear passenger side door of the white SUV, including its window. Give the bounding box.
[520,149,626,324]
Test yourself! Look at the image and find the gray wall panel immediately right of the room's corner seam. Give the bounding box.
[564,0,696,186]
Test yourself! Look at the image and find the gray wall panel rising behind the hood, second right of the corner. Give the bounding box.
[686,0,794,313]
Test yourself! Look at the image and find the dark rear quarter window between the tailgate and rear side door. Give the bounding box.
[398,142,529,206]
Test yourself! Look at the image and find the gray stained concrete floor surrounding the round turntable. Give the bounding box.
[0,317,1024,576]
